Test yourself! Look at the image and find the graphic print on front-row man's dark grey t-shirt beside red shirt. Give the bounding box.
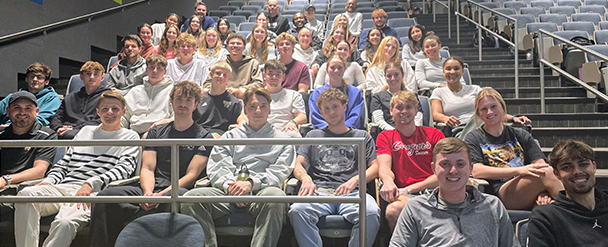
[317,145,356,173]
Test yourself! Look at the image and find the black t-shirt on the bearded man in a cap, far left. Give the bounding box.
[0,122,57,175]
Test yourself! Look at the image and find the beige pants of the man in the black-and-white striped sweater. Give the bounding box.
[15,184,91,247]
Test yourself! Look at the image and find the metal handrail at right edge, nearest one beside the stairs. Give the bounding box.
[538,29,608,113]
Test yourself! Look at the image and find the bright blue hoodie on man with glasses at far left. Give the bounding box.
[0,86,61,126]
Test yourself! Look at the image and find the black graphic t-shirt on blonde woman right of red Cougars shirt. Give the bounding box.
[465,125,546,192]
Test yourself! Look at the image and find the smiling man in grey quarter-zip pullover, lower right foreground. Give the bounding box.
[389,138,519,247]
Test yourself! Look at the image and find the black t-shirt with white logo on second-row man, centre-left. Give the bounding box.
[192,91,243,135]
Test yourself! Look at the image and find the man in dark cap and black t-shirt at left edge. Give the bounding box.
[0,91,57,194]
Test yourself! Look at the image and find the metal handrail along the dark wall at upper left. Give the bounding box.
[0,0,151,44]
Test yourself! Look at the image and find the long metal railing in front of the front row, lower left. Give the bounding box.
[0,137,367,246]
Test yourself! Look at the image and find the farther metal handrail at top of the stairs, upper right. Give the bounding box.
[456,0,519,99]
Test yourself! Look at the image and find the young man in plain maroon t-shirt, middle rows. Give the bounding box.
[277,33,310,93]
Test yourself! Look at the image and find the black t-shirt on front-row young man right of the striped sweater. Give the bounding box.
[144,122,213,188]
